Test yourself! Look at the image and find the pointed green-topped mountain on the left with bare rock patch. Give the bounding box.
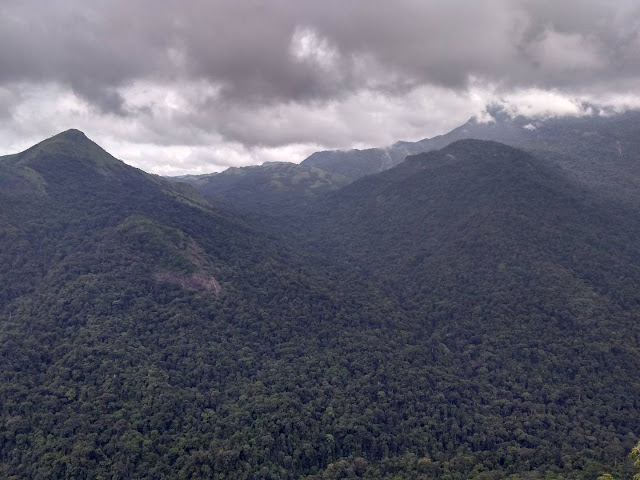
[0,131,396,479]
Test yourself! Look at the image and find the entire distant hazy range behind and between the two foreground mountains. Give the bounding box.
[173,109,640,214]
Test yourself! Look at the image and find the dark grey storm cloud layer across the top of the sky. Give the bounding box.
[0,0,640,111]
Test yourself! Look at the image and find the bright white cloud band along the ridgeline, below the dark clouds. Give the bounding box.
[0,79,640,175]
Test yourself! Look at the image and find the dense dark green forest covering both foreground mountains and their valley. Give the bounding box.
[0,129,640,480]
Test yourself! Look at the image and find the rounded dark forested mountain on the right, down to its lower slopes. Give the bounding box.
[302,140,640,478]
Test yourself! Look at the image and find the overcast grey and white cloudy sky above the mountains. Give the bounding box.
[0,0,640,175]
